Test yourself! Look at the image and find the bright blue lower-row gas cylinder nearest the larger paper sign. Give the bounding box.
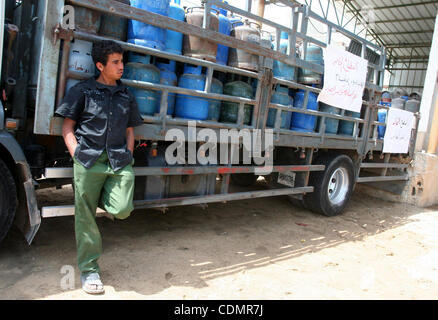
[291,90,318,132]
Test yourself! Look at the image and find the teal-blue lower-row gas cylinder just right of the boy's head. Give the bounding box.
[124,54,160,115]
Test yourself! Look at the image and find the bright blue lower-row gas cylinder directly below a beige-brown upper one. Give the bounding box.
[175,64,209,120]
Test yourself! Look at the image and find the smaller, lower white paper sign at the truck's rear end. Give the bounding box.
[383,109,414,153]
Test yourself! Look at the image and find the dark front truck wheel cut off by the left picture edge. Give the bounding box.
[0,159,18,242]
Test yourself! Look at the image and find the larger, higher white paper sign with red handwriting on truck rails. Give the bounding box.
[318,46,368,112]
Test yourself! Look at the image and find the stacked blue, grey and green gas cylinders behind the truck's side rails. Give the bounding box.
[67,0,368,135]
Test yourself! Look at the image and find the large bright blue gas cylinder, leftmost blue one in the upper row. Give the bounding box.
[128,0,169,50]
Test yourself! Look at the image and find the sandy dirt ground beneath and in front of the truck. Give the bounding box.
[0,182,438,300]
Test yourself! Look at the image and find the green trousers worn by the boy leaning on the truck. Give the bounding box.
[73,151,134,274]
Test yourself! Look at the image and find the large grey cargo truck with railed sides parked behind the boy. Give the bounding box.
[0,0,420,244]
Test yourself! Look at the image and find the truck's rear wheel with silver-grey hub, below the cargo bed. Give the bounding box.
[304,155,355,217]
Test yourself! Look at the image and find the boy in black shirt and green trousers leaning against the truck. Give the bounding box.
[56,41,143,294]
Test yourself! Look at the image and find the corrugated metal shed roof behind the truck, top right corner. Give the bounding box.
[342,0,438,60]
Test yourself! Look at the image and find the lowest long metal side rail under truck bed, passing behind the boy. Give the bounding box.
[41,187,313,218]
